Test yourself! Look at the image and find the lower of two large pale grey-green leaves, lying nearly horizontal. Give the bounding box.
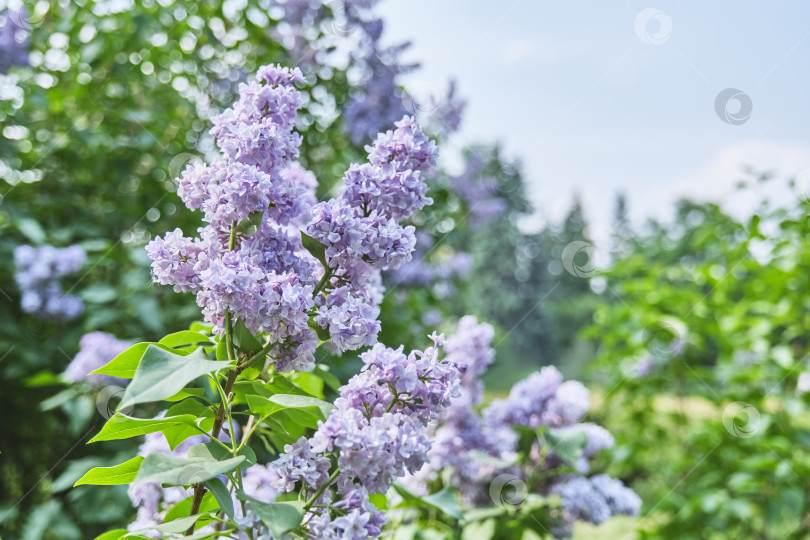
[133,454,245,486]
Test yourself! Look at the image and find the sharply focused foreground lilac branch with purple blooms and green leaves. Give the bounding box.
[80,66,464,538]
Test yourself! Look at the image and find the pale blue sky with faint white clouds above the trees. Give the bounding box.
[379,0,810,242]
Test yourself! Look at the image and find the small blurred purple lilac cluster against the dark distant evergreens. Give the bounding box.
[450,152,507,228]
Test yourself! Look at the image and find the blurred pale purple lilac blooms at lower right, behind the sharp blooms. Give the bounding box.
[407,317,641,536]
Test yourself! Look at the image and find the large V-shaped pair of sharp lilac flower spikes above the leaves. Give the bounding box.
[147,61,436,371]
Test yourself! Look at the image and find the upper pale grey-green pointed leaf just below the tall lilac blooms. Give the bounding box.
[119,345,228,408]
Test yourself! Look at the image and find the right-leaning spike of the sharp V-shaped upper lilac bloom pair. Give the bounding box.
[306,117,436,350]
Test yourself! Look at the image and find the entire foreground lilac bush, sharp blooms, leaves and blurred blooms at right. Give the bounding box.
[72,59,638,540]
